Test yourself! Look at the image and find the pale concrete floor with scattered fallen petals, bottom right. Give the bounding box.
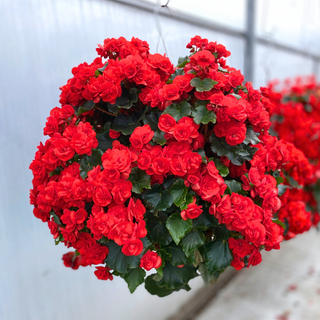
[195,228,320,320]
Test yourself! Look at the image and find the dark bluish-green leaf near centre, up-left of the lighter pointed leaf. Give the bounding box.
[142,183,173,212]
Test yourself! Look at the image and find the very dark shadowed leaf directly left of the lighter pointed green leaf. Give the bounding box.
[145,211,172,246]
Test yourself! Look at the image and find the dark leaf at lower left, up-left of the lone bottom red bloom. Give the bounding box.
[105,240,142,273]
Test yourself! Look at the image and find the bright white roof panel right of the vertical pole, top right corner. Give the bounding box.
[256,0,320,55]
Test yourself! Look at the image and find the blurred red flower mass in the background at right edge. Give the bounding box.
[264,77,320,239]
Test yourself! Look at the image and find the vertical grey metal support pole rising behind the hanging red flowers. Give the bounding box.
[244,0,255,81]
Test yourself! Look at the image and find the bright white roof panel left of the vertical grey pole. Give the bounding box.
[141,0,247,30]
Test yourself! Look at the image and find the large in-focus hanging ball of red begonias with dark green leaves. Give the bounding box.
[30,36,314,296]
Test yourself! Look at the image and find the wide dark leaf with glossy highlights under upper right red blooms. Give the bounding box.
[209,134,258,166]
